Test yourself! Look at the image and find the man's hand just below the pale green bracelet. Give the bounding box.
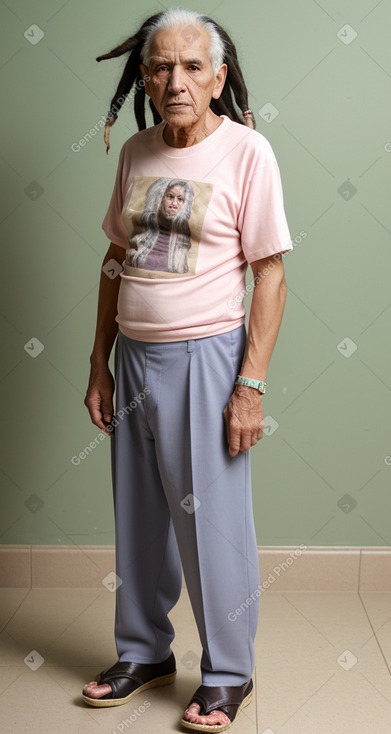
[224,385,265,456]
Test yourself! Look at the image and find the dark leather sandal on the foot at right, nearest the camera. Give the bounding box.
[180,678,254,732]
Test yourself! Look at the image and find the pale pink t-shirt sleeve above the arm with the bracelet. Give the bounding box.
[239,156,293,263]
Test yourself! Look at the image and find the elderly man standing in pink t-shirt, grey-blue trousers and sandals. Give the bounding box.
[82,9,292,732]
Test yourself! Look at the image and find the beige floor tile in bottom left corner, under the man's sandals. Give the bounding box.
[0,665,257,734]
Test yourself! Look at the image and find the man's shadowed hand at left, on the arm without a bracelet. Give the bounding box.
[84,366,115,436]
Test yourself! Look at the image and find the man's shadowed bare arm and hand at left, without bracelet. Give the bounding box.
[84,242,125,436]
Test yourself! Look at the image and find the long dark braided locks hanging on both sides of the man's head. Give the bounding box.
[96,11,255,153]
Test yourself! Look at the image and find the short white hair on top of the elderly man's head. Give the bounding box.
[140,8,225,74]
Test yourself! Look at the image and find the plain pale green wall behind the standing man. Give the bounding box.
[0,0,391,546]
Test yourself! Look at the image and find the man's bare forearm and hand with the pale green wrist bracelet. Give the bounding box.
[224,255,287,456]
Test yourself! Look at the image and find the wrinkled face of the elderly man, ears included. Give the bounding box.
[140,26,227,129]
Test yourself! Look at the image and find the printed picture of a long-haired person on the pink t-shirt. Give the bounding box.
[122,176,213,278]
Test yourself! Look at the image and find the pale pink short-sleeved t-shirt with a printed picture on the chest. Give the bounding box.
[102,115,293,342]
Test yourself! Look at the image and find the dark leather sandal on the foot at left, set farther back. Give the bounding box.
[82,652,176,707]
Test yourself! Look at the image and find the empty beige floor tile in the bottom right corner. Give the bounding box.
[257,663,391,734]
